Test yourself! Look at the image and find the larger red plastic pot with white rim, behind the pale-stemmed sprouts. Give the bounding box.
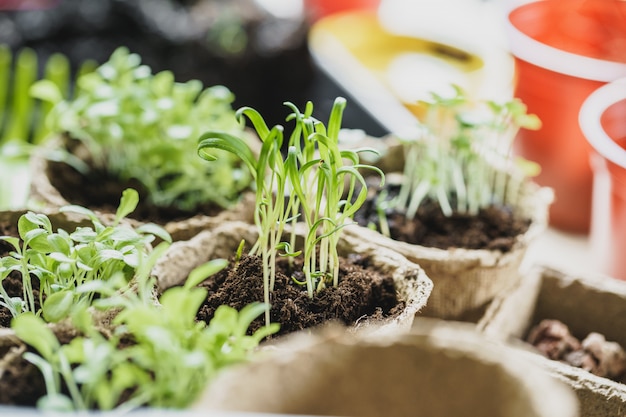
[506,0,626,233]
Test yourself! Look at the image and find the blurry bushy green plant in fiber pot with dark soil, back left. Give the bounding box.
[31,47,258,240]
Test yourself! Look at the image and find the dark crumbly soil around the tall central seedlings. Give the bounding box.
[198,255,405,335]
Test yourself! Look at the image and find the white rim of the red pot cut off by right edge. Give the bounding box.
[578,77,626,168]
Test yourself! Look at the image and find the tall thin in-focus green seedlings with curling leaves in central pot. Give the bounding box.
[198,98,383,323]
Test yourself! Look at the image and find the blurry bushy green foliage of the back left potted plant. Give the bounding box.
[33,47,251,211]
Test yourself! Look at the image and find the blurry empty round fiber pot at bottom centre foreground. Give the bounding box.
[194,319,578,417]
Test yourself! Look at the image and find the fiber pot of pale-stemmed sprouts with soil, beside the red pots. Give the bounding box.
[346,88,551,321]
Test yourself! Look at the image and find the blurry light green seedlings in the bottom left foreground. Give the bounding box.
[12,249,278,411]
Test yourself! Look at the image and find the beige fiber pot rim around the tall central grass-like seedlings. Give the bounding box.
[153,221,433,332]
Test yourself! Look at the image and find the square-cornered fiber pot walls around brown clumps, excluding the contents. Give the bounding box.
[477,266,626,417]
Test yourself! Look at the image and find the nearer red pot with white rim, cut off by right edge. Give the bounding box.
[580,78,626,280]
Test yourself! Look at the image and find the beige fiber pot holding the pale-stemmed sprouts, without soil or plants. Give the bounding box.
[345,138,553,321]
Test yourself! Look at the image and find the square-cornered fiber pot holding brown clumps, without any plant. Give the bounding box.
[478,266,626,417]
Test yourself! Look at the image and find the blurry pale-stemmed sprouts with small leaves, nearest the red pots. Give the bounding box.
[390,87,540,219]
